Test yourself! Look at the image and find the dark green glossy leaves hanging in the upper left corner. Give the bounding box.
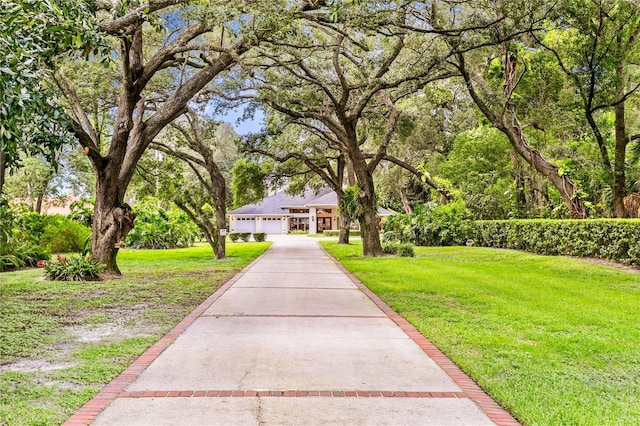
[0,0,104,171]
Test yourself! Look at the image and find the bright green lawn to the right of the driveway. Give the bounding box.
[321,241,640,425]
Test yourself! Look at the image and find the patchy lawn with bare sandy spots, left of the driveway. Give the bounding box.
[0,243,270,425]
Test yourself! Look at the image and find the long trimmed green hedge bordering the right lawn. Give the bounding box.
[469,219,640,266]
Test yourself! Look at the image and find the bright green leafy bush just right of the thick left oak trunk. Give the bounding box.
[126,197,201,249]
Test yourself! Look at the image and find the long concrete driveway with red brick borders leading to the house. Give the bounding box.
[66,236,518,425]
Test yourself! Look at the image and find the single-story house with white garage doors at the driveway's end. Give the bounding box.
[227,188,392,234]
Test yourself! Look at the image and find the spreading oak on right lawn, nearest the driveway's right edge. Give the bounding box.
[230,2,452,256]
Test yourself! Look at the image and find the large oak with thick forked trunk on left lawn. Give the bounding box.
[56,0,316,274]
